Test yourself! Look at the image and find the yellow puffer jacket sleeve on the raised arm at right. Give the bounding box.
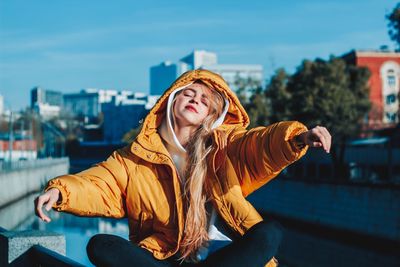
[227,121,308,196]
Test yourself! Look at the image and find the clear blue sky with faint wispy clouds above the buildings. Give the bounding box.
[0,0,397,110]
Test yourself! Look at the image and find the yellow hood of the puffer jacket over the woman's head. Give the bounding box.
[136,69,249,153]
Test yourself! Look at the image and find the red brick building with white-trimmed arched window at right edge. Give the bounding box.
[343,50,400,130]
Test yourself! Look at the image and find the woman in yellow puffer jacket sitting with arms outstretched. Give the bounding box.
[36,70,331,266]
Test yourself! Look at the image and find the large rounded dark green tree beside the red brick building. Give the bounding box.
[267,57,371,179]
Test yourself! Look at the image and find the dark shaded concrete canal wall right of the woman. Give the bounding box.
[249,178,400,241]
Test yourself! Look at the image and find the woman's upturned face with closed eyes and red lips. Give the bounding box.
[173,83,212,127]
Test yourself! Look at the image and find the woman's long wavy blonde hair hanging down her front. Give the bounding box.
[173,80,224,262]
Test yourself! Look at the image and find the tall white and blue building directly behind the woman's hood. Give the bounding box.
[150,50,264,95]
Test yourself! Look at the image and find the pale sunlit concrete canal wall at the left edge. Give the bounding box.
[0,158,69,208]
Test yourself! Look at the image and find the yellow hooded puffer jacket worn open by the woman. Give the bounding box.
[46,70,307,266]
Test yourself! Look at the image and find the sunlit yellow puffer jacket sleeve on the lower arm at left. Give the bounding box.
[45,149,128,218]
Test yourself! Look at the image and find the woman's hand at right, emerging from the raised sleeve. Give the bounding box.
[296,126,332,153]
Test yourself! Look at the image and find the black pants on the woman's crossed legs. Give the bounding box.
[87,221,282,267]
